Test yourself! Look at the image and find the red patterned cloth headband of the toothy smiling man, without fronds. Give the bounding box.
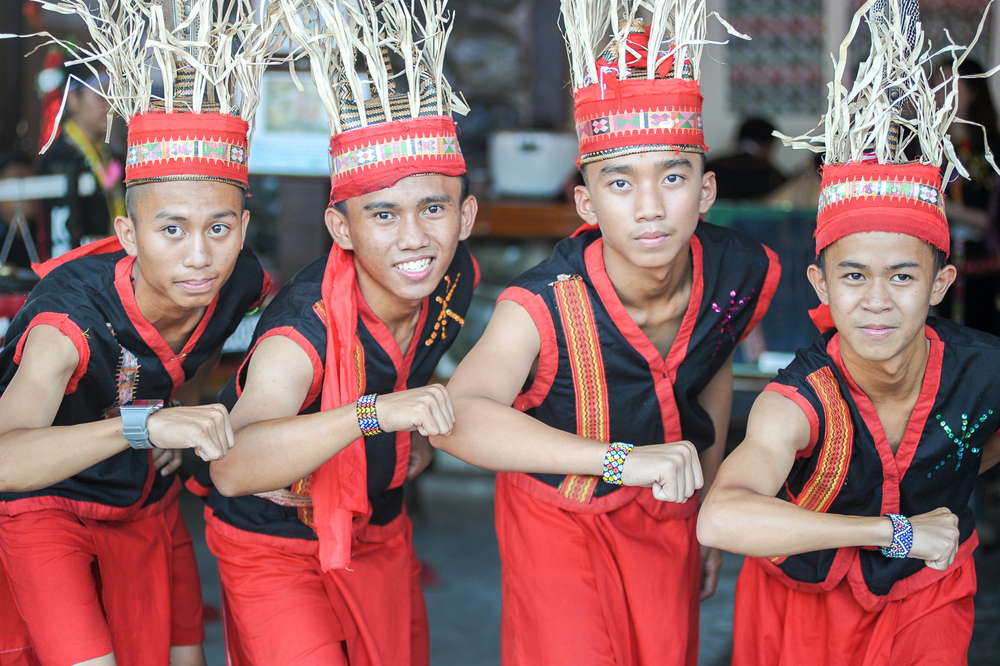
[330,116,465,205]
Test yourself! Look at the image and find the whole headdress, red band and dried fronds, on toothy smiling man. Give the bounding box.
[278,0,469,202]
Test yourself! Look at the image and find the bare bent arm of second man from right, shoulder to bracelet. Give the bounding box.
[431,300,608,476]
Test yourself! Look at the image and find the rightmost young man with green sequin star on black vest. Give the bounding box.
[698,3,1000,666]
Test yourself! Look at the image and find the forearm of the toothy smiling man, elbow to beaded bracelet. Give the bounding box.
[211,403,361,497]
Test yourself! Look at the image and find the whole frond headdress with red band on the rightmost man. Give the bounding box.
[775,0,996,254]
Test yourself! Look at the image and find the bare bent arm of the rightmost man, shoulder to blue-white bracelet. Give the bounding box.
[698,391,892,557]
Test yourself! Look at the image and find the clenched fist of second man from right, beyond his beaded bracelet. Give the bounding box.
[622,442,704,503]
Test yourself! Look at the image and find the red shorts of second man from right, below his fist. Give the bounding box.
[496,474,701,666]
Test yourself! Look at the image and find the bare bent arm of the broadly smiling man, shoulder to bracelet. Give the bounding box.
[211,336,361,497]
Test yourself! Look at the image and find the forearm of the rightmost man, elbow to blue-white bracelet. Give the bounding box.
[698,487,892,557]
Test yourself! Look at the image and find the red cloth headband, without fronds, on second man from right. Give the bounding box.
[573,76,708,165]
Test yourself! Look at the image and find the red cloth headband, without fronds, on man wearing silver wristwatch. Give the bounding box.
[125,112,249,189]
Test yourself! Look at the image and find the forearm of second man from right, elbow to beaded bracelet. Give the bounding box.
[431,396,608,476]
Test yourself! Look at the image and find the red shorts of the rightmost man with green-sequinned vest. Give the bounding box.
[733,557,976,666]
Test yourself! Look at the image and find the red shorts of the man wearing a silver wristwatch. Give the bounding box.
[0,500,205,666]
